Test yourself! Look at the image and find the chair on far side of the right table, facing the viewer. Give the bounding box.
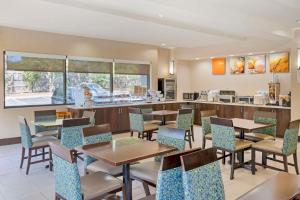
[245,111,277,142]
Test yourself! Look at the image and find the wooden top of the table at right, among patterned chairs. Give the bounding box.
[232,118,274,132]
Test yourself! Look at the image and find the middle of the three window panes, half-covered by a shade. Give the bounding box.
[67,58,113,104]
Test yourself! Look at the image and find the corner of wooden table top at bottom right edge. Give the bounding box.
[238,172,300,200]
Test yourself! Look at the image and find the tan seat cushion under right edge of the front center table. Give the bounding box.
[130,160,160,185]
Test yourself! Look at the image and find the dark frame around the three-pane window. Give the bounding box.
[2,50,152,109]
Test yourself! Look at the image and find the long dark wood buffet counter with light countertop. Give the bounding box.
[68,101,291,137]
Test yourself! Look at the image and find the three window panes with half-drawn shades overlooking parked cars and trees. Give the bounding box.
[5,52,149,107]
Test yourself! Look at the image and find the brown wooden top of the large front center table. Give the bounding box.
[75,137,176,166]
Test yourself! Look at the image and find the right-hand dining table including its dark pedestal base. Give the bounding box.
[232,118,274,167]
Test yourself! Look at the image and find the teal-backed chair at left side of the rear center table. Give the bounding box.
[128,108,158,140]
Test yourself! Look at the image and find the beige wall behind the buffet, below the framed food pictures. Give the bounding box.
[190,59,291,95]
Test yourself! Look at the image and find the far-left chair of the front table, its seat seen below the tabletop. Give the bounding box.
[82,124,122,177]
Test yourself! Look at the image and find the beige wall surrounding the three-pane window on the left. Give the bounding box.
[0,27,169,139]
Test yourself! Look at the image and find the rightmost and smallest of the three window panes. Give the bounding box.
[113,61,150,100]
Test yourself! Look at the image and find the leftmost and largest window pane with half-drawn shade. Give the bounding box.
[5,52,66,107]
